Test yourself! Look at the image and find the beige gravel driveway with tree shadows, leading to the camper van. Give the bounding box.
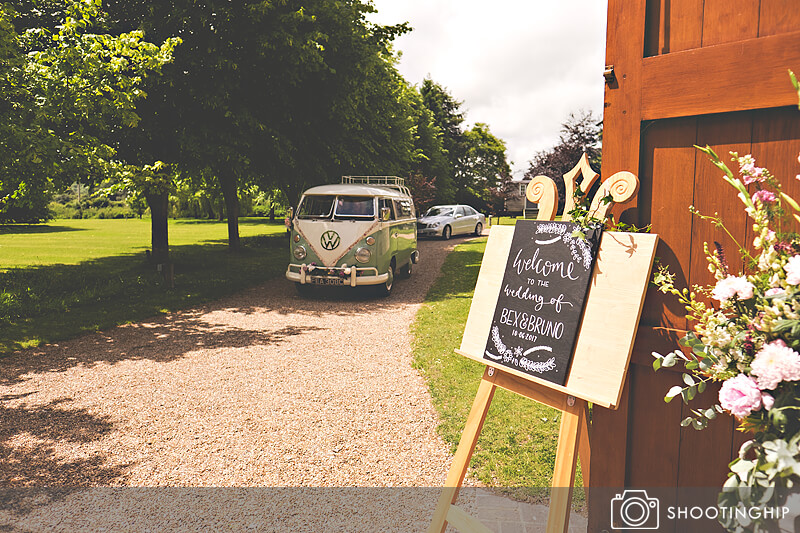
[0,241,476,487]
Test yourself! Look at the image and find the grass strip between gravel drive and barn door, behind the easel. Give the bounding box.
[412,238,582,500]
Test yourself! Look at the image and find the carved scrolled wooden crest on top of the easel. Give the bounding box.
[525,154,639,220]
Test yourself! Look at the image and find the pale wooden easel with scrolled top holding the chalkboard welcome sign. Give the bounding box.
[428,161,658,533]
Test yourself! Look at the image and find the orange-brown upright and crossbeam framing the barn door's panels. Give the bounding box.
[589,0,800,531]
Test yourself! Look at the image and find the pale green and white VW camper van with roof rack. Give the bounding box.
[286,176,419,295]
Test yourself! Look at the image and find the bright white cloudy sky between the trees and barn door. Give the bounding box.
[370,0,607,179]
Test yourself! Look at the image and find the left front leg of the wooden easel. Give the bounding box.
[428,367,496,533]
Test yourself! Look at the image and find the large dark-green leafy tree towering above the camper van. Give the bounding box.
[109,0,411,248]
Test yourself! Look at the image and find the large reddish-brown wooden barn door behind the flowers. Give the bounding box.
[589,0,800,531]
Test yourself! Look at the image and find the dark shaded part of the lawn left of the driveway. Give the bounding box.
[0,236,285,354]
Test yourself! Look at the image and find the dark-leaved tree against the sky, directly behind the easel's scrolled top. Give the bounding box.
[525,111,603,212]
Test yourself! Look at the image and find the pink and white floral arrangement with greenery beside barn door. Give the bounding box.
[653,146,800,531]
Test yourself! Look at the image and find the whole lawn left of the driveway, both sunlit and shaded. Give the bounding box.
[0,219,287,354]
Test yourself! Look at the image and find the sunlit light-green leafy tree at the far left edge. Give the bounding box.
[0,0,178,222]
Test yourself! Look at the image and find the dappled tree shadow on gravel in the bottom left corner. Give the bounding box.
[0,396,129,486]
